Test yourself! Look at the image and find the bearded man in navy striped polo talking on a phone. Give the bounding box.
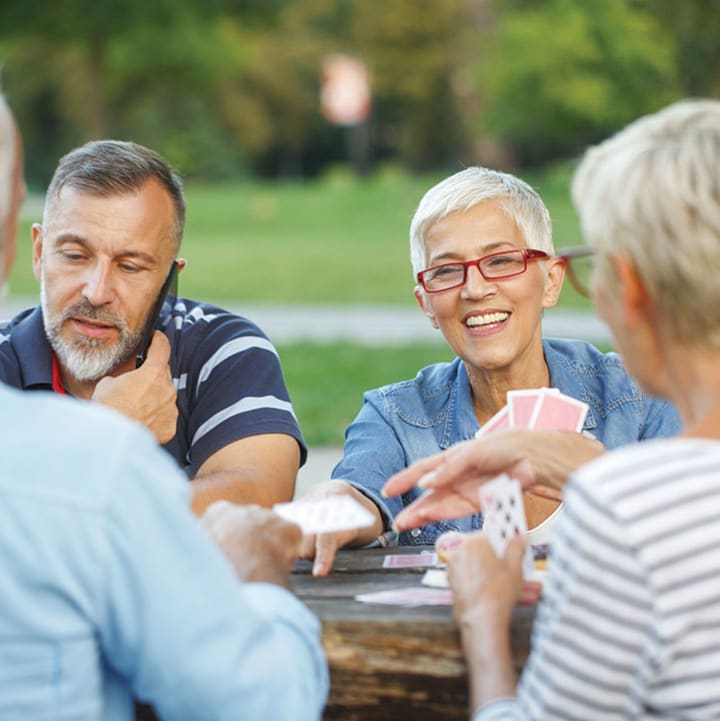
[0,141,306,512]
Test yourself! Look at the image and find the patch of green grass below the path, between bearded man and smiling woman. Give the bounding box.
[278,343,453,445]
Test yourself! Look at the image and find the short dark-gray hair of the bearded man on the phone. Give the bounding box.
[43,140,185,251]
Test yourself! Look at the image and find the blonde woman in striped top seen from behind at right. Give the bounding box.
[389,99,720,721]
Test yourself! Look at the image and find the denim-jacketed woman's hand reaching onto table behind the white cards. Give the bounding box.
[301,480,383,576]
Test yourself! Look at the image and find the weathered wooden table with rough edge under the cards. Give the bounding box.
[293,546,535,721]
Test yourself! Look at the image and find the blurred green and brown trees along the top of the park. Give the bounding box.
[0,0,720,185]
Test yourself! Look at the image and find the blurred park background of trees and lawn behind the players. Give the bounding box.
[0,0,720,444]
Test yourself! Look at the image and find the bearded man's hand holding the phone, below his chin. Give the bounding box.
[92,330,178,444]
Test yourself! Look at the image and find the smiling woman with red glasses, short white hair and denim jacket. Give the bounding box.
[303,167,680,575]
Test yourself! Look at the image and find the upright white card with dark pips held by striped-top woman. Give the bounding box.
[478,473,527,556]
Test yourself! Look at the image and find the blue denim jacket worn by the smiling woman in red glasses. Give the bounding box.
[332,338,680,545]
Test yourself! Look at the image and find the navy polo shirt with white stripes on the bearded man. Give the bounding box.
[0,298,307,478]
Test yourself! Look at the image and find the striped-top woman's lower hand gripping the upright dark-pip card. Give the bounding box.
[436,531,541,631]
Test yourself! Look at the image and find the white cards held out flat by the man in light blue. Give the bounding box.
[273,496,375,535]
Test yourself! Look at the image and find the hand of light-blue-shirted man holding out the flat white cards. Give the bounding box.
[200,501,302,588]
